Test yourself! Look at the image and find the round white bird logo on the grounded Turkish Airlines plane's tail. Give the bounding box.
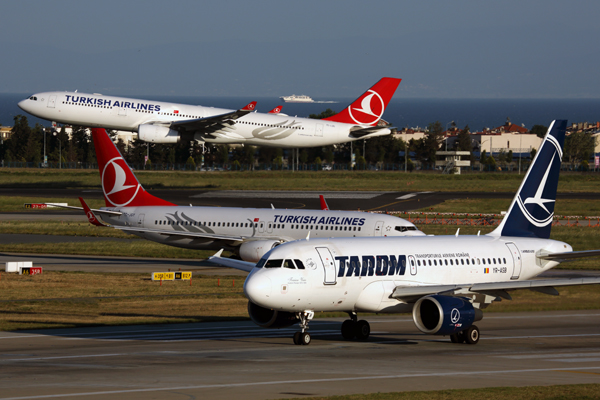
[102,157,141,207]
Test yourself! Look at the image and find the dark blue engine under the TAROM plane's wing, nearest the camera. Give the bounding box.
[413,295,483,335]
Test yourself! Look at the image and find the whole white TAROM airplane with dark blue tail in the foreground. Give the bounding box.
[210,121,600,344]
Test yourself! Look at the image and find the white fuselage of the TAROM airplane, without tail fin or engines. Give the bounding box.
[244,236,572,313]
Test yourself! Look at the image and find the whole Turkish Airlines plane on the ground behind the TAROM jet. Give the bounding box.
[56,128,424,262]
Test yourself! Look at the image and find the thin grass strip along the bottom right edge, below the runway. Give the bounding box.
[280,384,600,400]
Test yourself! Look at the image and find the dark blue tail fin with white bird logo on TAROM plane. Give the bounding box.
[490,120,567,239]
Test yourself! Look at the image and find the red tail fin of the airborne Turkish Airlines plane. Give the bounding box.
[324,78,401,126]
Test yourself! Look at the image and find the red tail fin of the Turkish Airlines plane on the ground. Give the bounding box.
[92,128,175,207]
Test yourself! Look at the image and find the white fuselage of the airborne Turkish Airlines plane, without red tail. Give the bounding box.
[19,92,390,148]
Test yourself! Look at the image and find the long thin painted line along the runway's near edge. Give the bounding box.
[0,366,600,400]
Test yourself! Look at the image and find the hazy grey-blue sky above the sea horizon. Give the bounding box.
[0,0,600,99]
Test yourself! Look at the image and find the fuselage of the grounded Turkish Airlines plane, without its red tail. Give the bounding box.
[102,206,423,253]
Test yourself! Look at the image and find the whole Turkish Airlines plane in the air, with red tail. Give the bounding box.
[19,78,400,148]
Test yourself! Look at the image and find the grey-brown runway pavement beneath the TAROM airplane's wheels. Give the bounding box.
[0,312,600,399]
